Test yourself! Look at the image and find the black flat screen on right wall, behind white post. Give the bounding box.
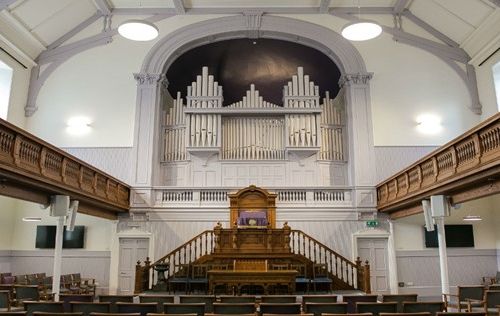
[424,225,474,248]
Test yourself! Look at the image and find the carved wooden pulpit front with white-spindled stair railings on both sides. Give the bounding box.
[135,226,370,293]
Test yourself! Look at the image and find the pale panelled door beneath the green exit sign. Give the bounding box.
[357,238,390,294]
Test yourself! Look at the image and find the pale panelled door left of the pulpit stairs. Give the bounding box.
[118,238,149,295]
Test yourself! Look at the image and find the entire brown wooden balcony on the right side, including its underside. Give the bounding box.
[377,113,500,218]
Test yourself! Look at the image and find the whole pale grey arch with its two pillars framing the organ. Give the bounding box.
[132,12,376,209]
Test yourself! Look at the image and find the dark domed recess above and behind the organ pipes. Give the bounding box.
[167,39,340,105]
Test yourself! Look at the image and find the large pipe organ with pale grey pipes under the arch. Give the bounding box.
[163,67,345,162]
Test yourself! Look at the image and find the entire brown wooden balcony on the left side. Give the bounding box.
[0,119,130,219]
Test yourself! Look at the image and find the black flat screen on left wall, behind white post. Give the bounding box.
[35,225,85,249]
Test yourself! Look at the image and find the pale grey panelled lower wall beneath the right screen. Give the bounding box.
[396,249,497,296]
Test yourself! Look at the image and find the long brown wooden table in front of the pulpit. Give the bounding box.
[207,270,297,295]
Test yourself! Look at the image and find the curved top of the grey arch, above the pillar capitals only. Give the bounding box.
[141,12,367,80]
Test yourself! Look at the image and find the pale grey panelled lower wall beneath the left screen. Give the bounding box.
[0,250,111,292]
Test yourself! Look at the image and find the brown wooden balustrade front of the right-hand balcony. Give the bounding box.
[377,114,500,212]
